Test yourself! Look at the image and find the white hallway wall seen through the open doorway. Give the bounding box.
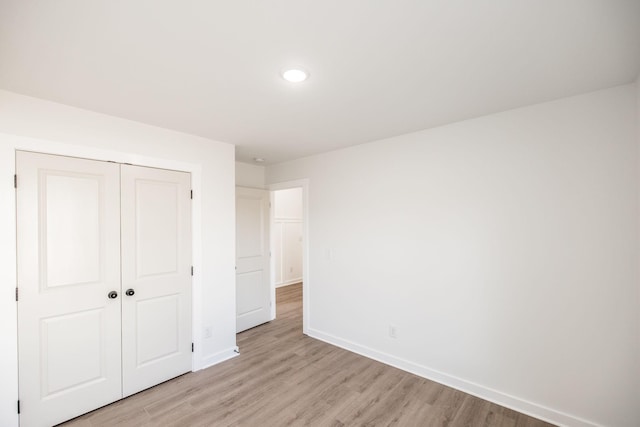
[272,188,302,287]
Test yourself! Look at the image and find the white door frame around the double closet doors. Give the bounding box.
[0,133,204,425]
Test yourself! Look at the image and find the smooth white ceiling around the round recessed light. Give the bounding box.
[0,0,640,164]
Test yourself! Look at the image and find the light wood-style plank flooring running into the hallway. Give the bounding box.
[63,285,550,427]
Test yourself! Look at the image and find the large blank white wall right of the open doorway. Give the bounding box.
[267,85,640,426]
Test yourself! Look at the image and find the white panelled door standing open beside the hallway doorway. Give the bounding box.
[236,187,271,332]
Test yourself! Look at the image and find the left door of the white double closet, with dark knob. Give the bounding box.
[16,152,122,426]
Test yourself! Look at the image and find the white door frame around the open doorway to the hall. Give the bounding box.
[267,178,311,335]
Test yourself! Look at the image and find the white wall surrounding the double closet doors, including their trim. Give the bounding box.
[0,91,236,426]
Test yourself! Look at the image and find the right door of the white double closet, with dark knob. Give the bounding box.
[121,165,191,397]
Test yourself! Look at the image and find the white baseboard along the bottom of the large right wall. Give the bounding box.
[308,328,602,427]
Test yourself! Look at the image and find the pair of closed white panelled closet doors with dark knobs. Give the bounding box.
[16,152,191,427]
